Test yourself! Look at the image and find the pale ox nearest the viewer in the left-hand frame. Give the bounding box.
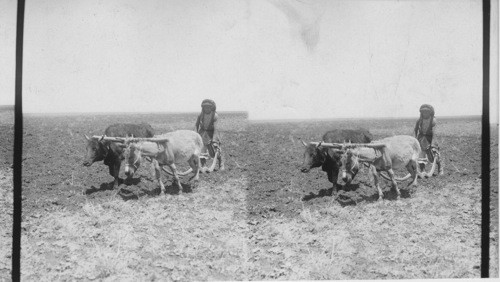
[124,130,203,193]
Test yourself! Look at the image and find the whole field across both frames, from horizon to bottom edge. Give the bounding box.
[0,113,498,281]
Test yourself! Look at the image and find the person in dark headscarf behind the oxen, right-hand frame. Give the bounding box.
[414,104,443,174]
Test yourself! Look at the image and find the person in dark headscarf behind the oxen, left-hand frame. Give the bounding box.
[195,99,225,171]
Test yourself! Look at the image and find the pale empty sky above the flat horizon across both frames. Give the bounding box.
[0,0,498,122]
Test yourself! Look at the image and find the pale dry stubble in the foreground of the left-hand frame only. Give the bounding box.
[22,178,248,281]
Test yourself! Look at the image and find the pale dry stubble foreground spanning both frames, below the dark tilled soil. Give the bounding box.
[5,169,488,281]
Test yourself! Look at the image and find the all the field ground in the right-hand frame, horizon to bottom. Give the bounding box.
[243,118,498,279]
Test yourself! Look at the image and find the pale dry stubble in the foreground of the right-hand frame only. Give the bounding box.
[251,182,481,280]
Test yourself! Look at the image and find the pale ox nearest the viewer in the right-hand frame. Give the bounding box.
[334,135,435,201]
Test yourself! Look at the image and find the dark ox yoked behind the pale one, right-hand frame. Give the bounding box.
[301,129,373,187]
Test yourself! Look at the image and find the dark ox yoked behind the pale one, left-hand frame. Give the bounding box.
[83,123,154,188]
